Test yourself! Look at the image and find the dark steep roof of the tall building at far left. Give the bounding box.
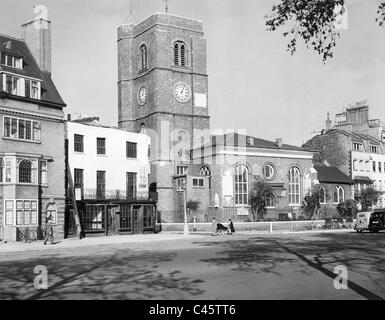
[0,35,66,108]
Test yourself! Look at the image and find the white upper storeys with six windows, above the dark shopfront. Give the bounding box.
[66,118,150,200]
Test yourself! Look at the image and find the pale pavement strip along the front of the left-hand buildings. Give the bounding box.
[0,232,205,255]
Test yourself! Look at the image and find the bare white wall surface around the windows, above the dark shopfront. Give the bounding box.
[66,122,150,197]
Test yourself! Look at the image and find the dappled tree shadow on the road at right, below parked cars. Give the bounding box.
[195,233,385,299]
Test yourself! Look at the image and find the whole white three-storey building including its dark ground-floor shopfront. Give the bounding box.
[66,117,156,235]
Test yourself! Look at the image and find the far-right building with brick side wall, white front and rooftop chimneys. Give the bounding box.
[303,102,385,207]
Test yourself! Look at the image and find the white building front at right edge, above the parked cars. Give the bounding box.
[351,151,385,208]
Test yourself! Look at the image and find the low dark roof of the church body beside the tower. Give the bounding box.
[203,132,309,152]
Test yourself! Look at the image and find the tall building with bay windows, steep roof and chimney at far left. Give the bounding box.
[0,19,65,240]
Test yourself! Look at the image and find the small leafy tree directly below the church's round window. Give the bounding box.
[250,179,274,221]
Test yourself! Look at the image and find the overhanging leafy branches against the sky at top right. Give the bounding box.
[266,0,385,63]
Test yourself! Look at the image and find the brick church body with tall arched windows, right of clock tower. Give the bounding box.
[188,133,318,221]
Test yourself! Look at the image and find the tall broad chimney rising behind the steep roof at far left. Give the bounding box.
[21,18,51,74]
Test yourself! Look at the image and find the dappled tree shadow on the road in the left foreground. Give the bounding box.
[0,250,204,300]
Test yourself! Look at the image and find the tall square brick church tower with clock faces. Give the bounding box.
[118,13,209,222]
